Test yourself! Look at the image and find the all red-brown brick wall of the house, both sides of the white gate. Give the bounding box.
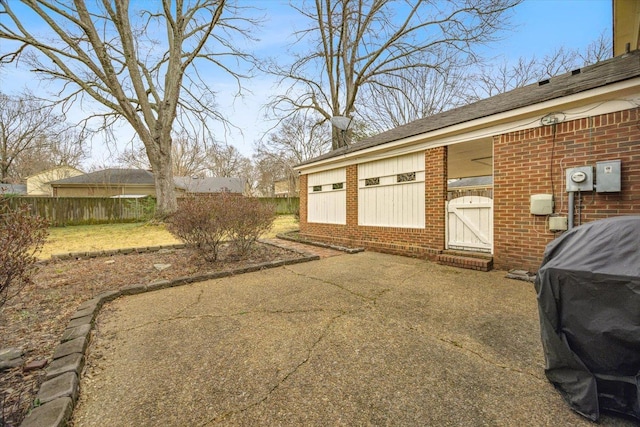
[300,109,640,271]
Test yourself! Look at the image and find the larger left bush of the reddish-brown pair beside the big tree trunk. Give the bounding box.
[167,196,228,262]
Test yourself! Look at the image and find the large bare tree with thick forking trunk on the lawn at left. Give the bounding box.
[0,0,253,216]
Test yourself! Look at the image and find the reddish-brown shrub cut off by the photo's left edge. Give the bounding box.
[0,199,48,308]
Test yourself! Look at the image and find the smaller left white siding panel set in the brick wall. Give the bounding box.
[307,168,347,224]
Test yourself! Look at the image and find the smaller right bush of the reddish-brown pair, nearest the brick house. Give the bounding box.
[225,196,276,257]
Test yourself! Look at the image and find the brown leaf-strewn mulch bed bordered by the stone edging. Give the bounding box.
[0,243,303,427]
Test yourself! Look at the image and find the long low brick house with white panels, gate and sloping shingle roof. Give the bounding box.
[296,49,640,271]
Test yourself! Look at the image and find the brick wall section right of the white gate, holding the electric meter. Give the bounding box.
[494,109,640,271]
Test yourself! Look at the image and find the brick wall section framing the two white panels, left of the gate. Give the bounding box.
[300,147,447,259]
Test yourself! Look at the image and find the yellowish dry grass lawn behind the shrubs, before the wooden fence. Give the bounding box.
[38,215,298,259]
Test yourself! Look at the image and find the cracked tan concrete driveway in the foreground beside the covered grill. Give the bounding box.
[73,252,634,427]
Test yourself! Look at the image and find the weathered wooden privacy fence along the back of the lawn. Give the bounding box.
[7,197,300,227]
